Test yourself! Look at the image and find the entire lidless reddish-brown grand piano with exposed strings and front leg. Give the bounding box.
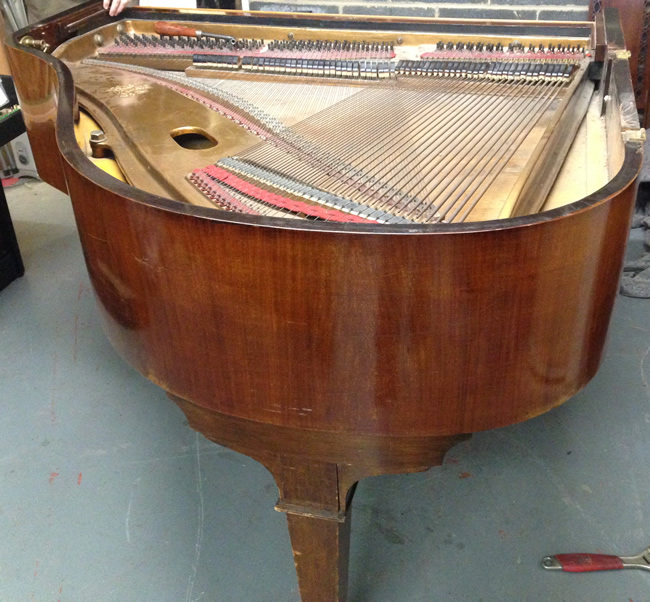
[8,2,644,602]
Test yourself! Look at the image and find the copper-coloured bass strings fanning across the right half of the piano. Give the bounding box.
[241,79,562,223]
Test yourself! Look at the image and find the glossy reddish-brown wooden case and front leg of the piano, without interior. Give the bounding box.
[8,3,642,601]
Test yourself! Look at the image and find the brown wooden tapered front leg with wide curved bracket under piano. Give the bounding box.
[168,393,469,602]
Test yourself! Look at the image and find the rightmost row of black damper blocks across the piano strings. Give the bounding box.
[395,61,574,81]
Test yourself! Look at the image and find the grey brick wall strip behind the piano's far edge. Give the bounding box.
[250,0,589,21]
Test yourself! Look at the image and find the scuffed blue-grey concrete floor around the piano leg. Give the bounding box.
[0,183,650,602]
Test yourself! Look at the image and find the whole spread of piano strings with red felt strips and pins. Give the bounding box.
[83,36,584,224]
